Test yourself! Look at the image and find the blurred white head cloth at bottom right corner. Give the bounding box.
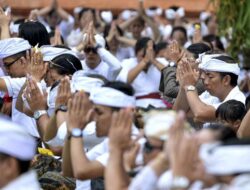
[200,144,250,175]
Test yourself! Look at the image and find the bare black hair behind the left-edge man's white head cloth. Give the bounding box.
[18,21,50,47]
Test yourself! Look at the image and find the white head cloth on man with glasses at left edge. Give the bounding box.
[0,38,31,59]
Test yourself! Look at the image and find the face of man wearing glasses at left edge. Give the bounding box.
[3,57,26,78]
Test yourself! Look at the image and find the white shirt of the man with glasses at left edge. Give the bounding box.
[1,76,39,137]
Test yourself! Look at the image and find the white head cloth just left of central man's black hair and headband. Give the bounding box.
[71,71,104,93]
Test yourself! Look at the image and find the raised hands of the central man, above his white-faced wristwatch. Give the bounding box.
[66,91,93,131]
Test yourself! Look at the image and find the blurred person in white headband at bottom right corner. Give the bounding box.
[200,139,250,189]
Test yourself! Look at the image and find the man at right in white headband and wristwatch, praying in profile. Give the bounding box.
[174,55,245,126]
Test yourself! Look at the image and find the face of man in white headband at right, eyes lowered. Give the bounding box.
[201,71,224,97]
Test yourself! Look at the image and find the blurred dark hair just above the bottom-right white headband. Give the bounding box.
[208,124,237,142]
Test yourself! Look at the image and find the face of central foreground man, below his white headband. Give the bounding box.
[94,105,113,137]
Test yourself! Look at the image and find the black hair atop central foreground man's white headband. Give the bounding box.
[103,81,134,96]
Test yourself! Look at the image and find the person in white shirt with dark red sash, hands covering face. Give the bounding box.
[117,38,168,108]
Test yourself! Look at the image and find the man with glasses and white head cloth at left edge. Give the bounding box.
[0,38,39,137]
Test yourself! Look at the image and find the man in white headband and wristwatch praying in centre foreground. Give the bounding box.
[63,82,138,189]
